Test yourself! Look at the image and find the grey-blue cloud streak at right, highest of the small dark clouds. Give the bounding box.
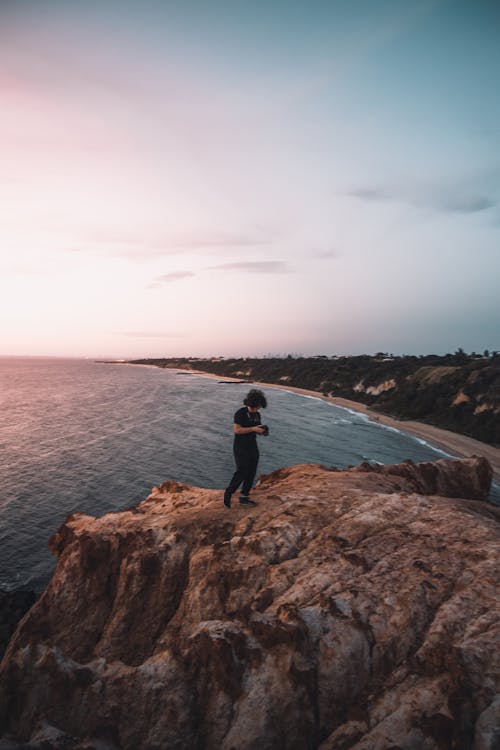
[347,185,497,214]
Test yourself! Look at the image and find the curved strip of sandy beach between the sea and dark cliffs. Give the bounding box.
[127,363,500,482]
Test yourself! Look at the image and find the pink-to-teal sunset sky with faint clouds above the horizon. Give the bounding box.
[0,0,500,358]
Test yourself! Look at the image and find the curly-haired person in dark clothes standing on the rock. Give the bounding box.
[224,389,268,508]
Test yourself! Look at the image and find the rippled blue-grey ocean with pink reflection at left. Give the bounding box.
[0,357,496,591]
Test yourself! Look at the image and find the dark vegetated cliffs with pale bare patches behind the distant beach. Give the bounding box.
[129,352,500,446]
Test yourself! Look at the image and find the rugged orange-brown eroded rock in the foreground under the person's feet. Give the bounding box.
[0,459,500,750]
